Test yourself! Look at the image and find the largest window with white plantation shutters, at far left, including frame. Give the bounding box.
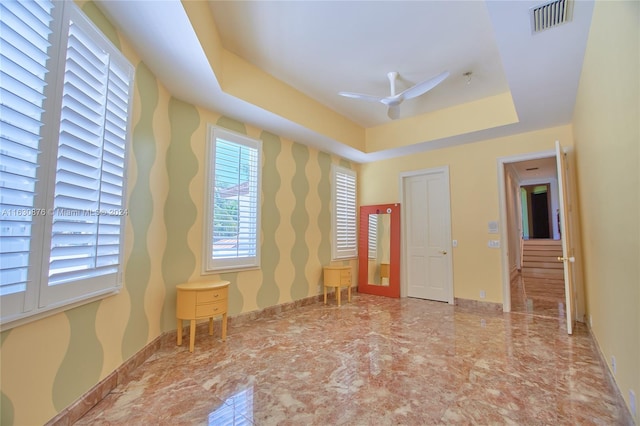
[0,0,134,326]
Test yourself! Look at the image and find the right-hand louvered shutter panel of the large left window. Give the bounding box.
[49,18,109,284]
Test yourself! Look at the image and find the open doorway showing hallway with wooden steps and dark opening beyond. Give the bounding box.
[504,154,566,320]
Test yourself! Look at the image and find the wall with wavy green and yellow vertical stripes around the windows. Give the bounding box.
[0,2,357,425]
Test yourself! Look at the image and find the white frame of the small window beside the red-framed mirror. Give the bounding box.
[331,164,358,260]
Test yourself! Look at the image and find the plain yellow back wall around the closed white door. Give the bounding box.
[359,125,573,303]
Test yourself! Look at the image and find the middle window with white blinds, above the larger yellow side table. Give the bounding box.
[203,126,262,273]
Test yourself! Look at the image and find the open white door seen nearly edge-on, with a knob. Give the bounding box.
[556,141,576,334]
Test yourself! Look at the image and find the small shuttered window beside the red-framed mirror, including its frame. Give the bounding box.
[331,164,358,259]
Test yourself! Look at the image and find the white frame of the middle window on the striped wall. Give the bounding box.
[201,124,263,275]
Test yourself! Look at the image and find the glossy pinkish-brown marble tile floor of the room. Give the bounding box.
[76,293,632,426]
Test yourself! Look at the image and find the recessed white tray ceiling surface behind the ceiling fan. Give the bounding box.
[210,1,509,127]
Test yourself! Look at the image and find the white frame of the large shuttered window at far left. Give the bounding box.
[0,1,135,330]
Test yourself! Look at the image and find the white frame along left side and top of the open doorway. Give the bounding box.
[498,150,556,312]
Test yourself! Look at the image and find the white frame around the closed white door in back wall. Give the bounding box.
[398,166,454,305]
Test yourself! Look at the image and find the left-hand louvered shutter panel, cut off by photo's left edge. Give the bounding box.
[0,1,53,316]
